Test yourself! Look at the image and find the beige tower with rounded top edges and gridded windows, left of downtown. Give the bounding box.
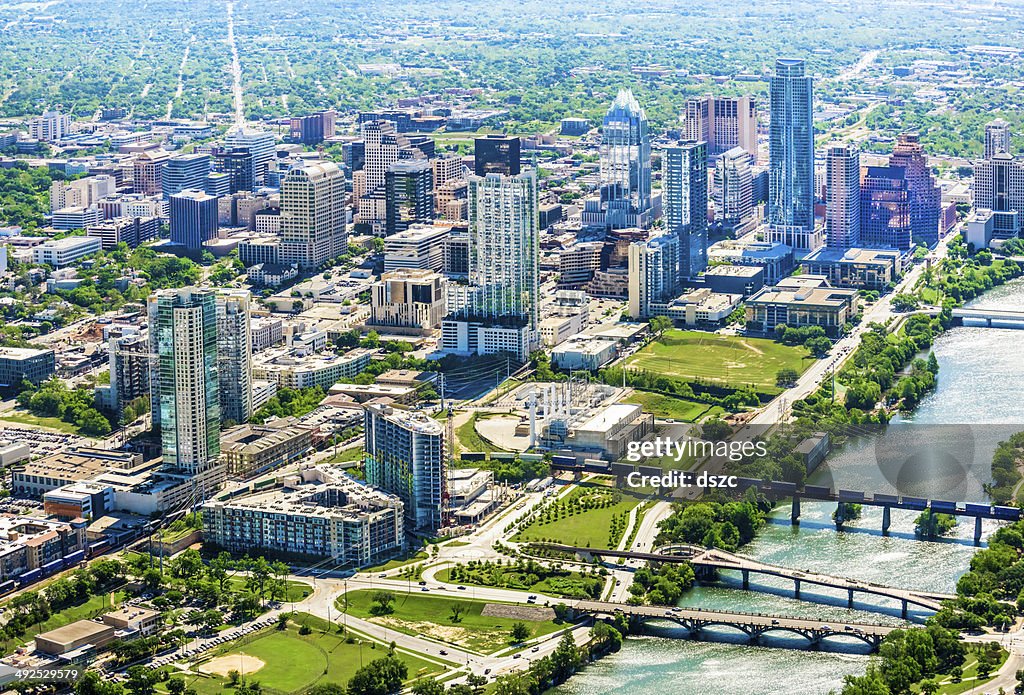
[281,162,348,268]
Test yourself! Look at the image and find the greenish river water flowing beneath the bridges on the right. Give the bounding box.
[554,278,1024,695]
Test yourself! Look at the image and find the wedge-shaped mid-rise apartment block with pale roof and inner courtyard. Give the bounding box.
[203,466,404,566]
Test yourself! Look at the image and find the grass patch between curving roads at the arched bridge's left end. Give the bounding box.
[339,590,561,654]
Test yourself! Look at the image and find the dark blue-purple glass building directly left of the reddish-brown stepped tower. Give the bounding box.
[860,167,913,251]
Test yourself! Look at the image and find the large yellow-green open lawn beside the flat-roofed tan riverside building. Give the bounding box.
[626,331,814,392]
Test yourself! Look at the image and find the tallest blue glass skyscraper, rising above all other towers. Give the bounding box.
[768,58,814,228]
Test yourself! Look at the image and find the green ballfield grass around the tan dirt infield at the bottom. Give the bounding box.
[178,613,442,695]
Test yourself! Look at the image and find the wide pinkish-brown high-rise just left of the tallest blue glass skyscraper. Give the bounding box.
[684,94,758,160]
